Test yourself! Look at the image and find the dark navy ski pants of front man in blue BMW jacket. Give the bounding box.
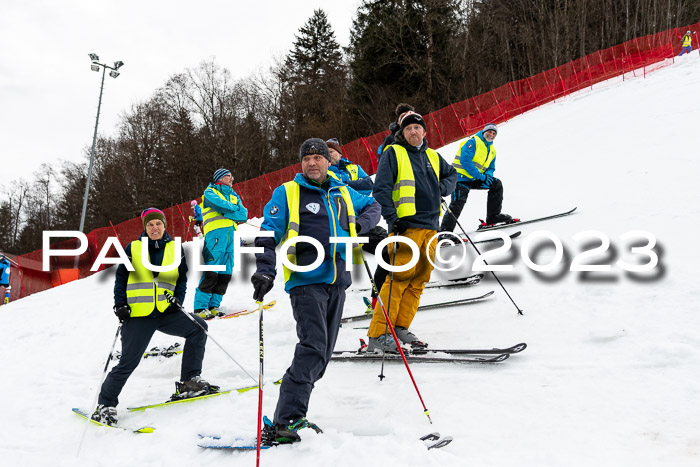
[274,284,345,425]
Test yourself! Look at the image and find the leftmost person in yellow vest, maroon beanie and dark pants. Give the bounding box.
[92,208,219,425]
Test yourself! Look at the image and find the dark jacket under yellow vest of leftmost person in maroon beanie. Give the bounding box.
[114,231,187,318]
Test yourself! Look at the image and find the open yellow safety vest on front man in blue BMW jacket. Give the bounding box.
[280,181,362,282]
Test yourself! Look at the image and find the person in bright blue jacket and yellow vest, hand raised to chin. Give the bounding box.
[440,123,513,238]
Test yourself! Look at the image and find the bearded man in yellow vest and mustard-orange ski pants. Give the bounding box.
[367,111,457,352]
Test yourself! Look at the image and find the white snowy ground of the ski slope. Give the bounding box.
[0,53,700,466]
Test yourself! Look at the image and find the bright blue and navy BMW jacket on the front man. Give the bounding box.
[255,173,380,292]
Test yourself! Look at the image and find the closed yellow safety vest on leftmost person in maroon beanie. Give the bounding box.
[126,240,179,318]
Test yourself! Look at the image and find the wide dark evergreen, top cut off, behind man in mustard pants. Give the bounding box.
[348,0,460,136]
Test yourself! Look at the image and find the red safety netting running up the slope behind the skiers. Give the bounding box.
[10,23,700,300]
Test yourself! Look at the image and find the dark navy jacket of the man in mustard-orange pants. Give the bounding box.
[374,133,457,233]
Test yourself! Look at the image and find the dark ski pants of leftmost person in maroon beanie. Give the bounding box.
[97,311,208,407]
